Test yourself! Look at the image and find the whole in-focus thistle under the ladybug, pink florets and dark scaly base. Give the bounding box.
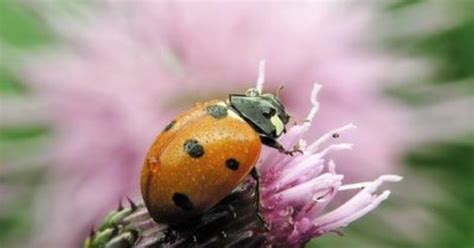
[86,76,402,247]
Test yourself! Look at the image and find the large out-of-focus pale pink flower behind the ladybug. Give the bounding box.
[16,1,405,247]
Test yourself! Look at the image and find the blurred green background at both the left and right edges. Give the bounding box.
[0,0,474,248]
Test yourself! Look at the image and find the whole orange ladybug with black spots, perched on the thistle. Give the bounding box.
[140,88,297,223]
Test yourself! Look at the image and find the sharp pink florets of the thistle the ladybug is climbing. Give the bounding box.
[258,81,402,247]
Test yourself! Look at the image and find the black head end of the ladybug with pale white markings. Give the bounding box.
[229,88,290,138]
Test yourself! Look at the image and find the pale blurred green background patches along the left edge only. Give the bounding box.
[0,0,52,244]
